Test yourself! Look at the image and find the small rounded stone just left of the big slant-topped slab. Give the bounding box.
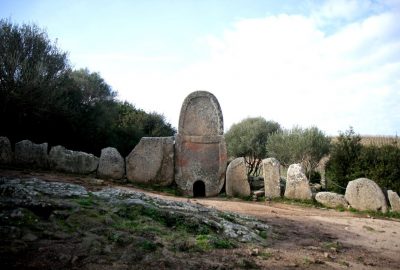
[97,147,125,180]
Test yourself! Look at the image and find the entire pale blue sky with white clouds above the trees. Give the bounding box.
[0,0,400,135]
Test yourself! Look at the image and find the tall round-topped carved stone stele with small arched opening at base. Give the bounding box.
[175,91,227,196]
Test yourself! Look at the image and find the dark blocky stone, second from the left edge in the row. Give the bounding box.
[15,140,48,168]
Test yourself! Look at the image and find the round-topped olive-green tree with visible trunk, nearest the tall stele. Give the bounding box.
[225,117,280,176]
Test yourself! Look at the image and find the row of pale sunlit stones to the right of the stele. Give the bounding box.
[226,158,400,213]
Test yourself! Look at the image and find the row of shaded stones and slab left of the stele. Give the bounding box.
[0,137,174,186]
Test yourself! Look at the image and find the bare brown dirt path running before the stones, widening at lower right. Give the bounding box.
[0,170,400,269]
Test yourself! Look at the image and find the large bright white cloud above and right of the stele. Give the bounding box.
[167,6,400,134]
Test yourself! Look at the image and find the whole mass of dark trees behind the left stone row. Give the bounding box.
[0,20,175,155]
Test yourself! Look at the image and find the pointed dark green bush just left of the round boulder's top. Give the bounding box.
[326,127,362,193]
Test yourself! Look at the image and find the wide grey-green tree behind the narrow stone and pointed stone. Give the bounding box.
[266,127,330,178]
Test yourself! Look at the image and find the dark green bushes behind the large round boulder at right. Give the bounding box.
[326,128,400,193]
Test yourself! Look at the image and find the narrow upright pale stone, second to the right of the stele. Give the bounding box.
[262,158,281,199]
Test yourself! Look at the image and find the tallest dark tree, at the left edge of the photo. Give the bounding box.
[0,20,70,141]
